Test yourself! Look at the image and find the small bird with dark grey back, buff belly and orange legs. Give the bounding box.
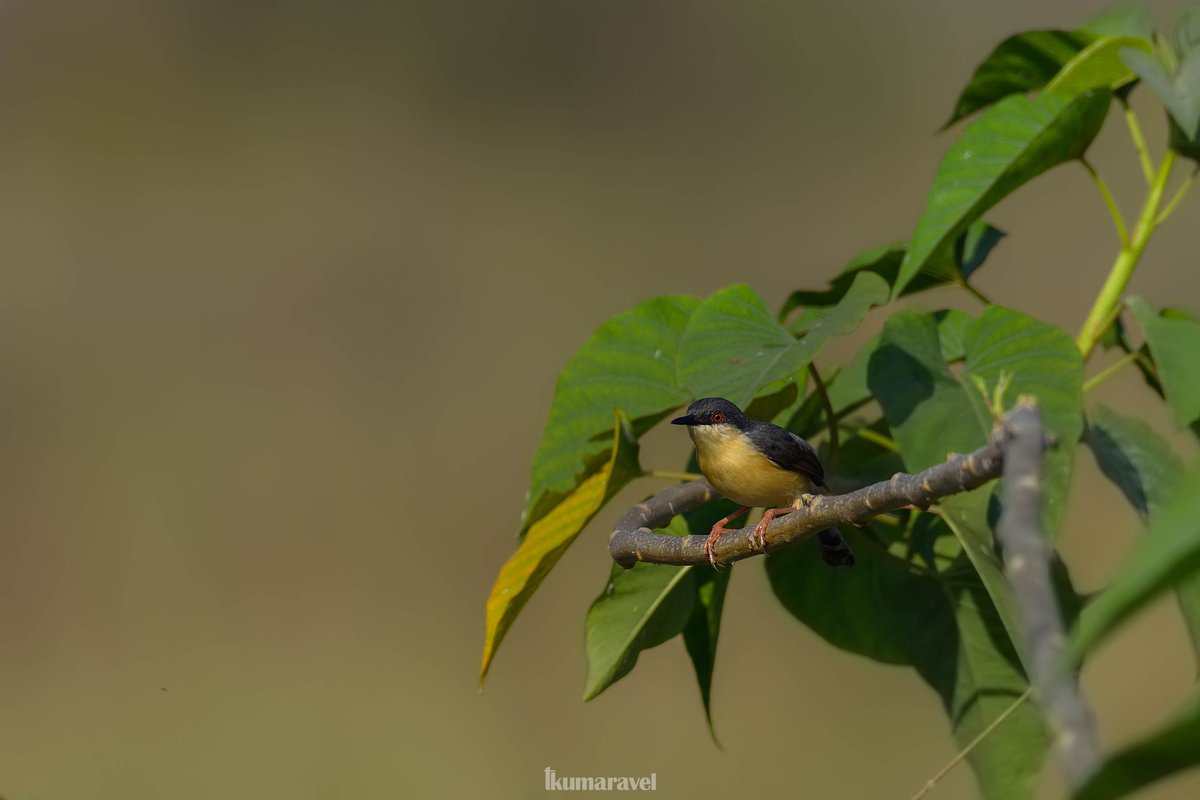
[671,397,854,567]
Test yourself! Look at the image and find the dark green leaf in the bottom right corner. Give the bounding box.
[1075,694,1200,800]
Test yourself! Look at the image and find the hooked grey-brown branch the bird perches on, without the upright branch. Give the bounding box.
[608,407,1021,569]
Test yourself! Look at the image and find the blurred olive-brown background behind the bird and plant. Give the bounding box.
[0,0,1200,800]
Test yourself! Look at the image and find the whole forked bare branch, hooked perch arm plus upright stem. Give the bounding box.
[608,397,1099,788]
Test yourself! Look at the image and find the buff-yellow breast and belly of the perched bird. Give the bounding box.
[689,425,809,509]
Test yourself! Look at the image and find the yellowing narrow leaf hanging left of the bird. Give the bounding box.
[479,410,642,685]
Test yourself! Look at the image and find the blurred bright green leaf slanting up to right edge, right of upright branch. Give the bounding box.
[1072,470,1200,658]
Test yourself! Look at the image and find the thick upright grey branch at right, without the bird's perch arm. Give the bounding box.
[996,401,1100,789]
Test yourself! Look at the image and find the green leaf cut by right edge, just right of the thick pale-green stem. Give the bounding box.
[1126,297,1200,426]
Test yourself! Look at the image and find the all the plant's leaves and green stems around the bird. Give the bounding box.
[481,12,1200,800]
